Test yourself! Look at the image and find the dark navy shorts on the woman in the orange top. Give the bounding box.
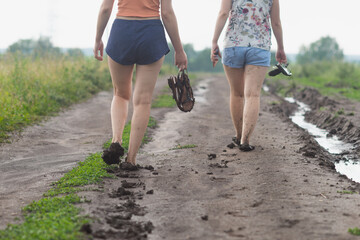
[105,19,170,65]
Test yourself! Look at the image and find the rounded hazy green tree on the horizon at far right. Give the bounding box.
[296,36,344,64]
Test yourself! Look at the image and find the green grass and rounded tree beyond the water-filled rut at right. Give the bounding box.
[270,37,360,101]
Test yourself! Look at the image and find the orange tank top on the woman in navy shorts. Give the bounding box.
[116,0,160,17]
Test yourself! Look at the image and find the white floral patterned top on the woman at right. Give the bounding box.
[224,0,273,51]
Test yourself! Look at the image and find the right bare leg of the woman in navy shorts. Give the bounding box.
[127,57,164,164]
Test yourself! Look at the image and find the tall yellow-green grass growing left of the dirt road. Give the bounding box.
[0,55,111,142]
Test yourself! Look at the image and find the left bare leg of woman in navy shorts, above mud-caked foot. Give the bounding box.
[108,57,134,144]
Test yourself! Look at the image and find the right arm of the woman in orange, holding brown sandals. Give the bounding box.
[161,0,188,69]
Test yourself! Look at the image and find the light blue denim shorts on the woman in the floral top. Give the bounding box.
[222,47,271,68]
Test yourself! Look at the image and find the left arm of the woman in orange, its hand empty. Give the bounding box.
[94,0,114,61]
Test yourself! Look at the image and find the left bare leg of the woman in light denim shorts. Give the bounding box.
[224,65,244,140]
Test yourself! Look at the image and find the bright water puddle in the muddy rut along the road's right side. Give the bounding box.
[286,96,360,183]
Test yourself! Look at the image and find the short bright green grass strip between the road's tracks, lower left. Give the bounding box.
[0,117,156,240]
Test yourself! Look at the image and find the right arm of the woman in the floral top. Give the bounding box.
[270,0,287,63]
